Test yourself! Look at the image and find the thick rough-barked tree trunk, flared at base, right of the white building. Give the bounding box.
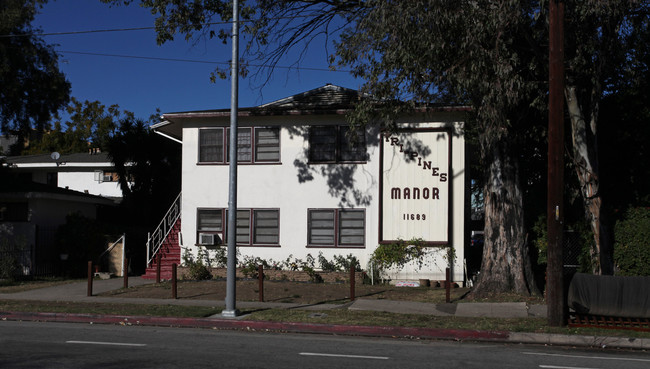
[471,137,539,298]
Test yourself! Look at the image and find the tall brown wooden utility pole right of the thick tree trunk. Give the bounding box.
[546,0,566,327]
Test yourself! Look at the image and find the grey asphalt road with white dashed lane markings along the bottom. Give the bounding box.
[0,321,650,369]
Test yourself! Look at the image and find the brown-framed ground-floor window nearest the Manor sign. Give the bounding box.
[307,209,366,247]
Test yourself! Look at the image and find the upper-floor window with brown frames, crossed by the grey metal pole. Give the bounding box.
[199,127,280,164]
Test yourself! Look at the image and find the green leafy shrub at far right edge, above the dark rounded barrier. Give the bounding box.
[614,208,650,276]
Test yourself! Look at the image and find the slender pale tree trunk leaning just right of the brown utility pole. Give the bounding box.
[565,86,614,274]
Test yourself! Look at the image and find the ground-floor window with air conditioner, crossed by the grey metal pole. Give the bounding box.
[196,209,280,246]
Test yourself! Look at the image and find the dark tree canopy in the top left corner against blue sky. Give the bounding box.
[0,0,70,133]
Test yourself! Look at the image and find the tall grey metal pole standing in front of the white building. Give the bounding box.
[221,0,239,318]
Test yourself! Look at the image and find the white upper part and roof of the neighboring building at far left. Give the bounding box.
[6,149,122,201]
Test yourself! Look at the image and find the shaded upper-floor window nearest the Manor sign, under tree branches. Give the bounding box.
[309,126,367,163]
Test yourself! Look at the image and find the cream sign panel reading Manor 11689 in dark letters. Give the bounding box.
[380,129,451,244]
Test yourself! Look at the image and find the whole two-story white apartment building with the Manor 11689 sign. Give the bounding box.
[153,85,469,281]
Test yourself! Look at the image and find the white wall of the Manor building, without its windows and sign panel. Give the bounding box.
[182,113,466,281]
